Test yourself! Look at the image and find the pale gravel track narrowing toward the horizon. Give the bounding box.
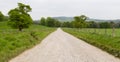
[10,28,120,62]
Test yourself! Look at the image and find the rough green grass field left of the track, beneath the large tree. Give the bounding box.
[0,22,55,62]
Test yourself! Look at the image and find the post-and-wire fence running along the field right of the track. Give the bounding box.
[68,28,120,37]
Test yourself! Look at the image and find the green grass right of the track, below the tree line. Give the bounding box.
[63,28,120,58]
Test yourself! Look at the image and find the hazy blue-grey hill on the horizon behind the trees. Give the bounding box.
[53,16,120,22]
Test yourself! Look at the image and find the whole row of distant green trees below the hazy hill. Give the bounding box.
[40,15,120,28]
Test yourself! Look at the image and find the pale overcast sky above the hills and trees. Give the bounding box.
[0,0,120,20]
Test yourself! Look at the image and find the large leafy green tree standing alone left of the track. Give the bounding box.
[8,3,32,31]
